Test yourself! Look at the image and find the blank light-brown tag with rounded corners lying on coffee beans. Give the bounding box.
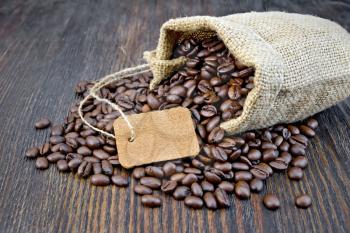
[113,107,199,168]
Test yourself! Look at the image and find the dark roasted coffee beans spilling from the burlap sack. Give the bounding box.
[26,37,318,209]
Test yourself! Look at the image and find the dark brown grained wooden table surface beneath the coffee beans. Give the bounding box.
[0,0,350,233]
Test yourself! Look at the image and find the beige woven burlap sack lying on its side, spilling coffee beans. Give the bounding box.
[144,12,350,133]
